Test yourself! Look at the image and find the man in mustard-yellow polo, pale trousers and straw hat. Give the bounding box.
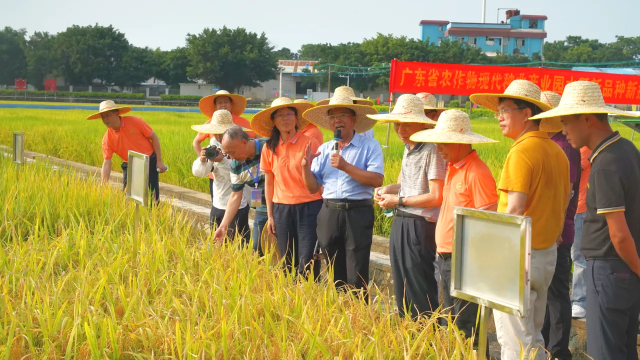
[471,80,571,360]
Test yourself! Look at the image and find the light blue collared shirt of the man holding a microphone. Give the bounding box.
[311,133,384,200]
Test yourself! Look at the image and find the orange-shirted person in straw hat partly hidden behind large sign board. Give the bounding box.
[411,109,498,346]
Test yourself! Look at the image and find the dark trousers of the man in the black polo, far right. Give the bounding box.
[585,259,640,360]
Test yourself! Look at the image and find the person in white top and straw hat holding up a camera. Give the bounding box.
[191,110,250,244]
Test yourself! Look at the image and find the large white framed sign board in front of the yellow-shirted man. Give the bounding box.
[451,207,531,317]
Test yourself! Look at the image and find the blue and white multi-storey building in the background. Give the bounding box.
[420,10,547,57]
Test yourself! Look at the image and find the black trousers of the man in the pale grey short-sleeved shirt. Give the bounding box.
[389,212,438,318]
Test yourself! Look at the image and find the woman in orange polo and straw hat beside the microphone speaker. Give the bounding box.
[251,97,322,276]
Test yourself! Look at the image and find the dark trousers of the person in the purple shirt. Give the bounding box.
[542,244,572,360]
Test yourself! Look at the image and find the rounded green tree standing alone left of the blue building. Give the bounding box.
[187,27,278,91]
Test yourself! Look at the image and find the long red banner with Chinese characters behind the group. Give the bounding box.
[389,60,640,104]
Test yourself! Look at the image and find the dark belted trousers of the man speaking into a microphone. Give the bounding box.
[317,200,374,301]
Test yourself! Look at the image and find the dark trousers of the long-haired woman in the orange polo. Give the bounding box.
[273,200,322,279]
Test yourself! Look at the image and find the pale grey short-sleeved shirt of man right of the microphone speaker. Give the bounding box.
[398,143,447,222]
